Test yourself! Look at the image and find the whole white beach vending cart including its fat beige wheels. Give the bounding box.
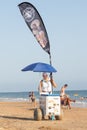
[34,94,63,120]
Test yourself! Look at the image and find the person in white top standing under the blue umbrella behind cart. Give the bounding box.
[38,73,57,94]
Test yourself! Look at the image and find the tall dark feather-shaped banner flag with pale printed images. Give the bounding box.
[18,2,50,55]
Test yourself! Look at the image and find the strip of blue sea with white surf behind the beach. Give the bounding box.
[0,90,87,108]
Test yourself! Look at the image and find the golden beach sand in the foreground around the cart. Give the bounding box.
[0,102,87,130]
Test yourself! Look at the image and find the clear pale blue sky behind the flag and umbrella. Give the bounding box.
[0,0,87,92]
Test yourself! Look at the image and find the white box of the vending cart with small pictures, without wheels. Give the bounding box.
[39,94,61,116]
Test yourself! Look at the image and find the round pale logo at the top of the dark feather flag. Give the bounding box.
[23,7,35,22]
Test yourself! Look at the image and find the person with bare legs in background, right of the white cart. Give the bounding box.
[60,84,75,109]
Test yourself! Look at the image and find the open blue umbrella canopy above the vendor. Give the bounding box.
[22,62,57,73]
